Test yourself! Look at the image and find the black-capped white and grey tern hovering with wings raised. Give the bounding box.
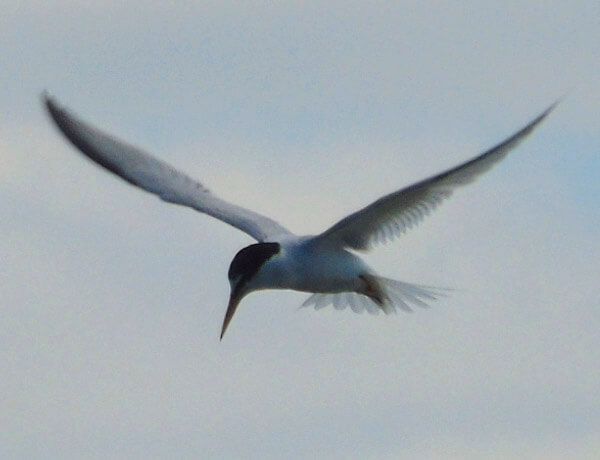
[42,92,558,341]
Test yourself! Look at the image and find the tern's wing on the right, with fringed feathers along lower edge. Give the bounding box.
[314,103,557,250]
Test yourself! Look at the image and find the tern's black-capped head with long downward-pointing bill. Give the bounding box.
[221,243,281,339]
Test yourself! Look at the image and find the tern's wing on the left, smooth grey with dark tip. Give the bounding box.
[44,95,291,241]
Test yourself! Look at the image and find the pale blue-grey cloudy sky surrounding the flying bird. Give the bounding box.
[0,0,600,459]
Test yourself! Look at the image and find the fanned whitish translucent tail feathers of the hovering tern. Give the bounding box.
[302,276,451,315]
